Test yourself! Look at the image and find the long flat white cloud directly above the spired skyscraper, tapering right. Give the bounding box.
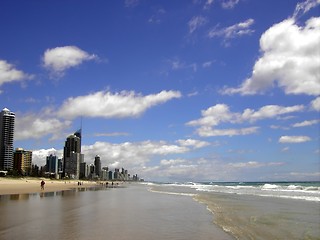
[58,91,181,119]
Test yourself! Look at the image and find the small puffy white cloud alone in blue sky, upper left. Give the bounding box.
[42,46,97,77]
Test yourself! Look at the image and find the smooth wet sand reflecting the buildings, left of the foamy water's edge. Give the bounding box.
[0,184,233,240]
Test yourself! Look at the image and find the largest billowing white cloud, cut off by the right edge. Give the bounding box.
[221,15,320,95]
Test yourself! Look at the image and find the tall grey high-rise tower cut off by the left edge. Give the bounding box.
[0,108,15,170]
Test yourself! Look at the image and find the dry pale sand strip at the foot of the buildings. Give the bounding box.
[0,178,98,195]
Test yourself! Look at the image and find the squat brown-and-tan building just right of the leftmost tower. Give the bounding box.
[13,148,32,175]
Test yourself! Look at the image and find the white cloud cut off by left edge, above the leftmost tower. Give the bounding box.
[0,60,32,86]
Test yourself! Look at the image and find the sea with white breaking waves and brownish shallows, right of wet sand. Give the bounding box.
[149,182,320,240]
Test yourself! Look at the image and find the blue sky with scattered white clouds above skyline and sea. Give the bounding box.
[0,0,320,182]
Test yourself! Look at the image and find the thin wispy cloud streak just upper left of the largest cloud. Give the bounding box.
[208,18,254,39]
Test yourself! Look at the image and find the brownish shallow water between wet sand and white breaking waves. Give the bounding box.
[150,184,320,240]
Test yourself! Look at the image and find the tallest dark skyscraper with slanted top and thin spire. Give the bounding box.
[63,132,84,179]
